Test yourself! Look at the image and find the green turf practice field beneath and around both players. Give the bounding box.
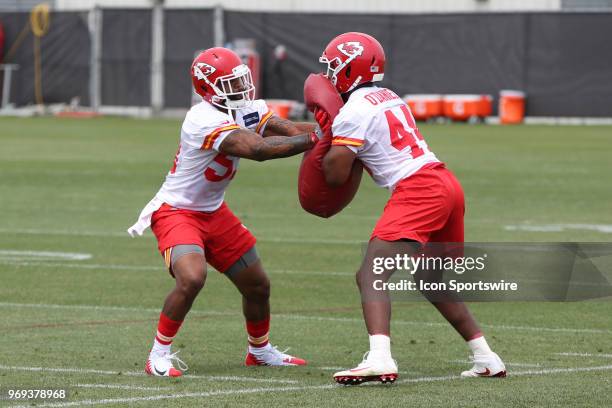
[0,118,612,408]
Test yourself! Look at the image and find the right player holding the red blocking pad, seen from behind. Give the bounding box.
[315,32,506,385]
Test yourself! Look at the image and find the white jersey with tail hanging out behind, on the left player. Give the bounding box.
[128,99,273,239]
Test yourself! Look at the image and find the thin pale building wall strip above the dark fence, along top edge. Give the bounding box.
[55,0,561,13]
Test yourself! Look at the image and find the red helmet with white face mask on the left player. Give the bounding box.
[191,47,255,109]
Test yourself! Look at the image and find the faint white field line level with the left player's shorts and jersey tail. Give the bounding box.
[0,227,367,245]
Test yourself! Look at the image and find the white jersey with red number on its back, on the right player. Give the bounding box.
[332,86,439,189]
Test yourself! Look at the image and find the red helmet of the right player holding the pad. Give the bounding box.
[319,32,385,94]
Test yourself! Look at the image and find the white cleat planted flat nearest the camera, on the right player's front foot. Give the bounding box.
[334,352,398,385]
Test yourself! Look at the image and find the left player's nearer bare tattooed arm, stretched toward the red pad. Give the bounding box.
[219,129,318,161]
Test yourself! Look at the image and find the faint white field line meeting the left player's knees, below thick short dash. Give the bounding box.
[0,258,355,276]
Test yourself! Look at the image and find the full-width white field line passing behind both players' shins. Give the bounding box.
[0,302,612,334]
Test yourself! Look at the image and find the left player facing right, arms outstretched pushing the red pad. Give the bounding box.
[128,48,318,377]
